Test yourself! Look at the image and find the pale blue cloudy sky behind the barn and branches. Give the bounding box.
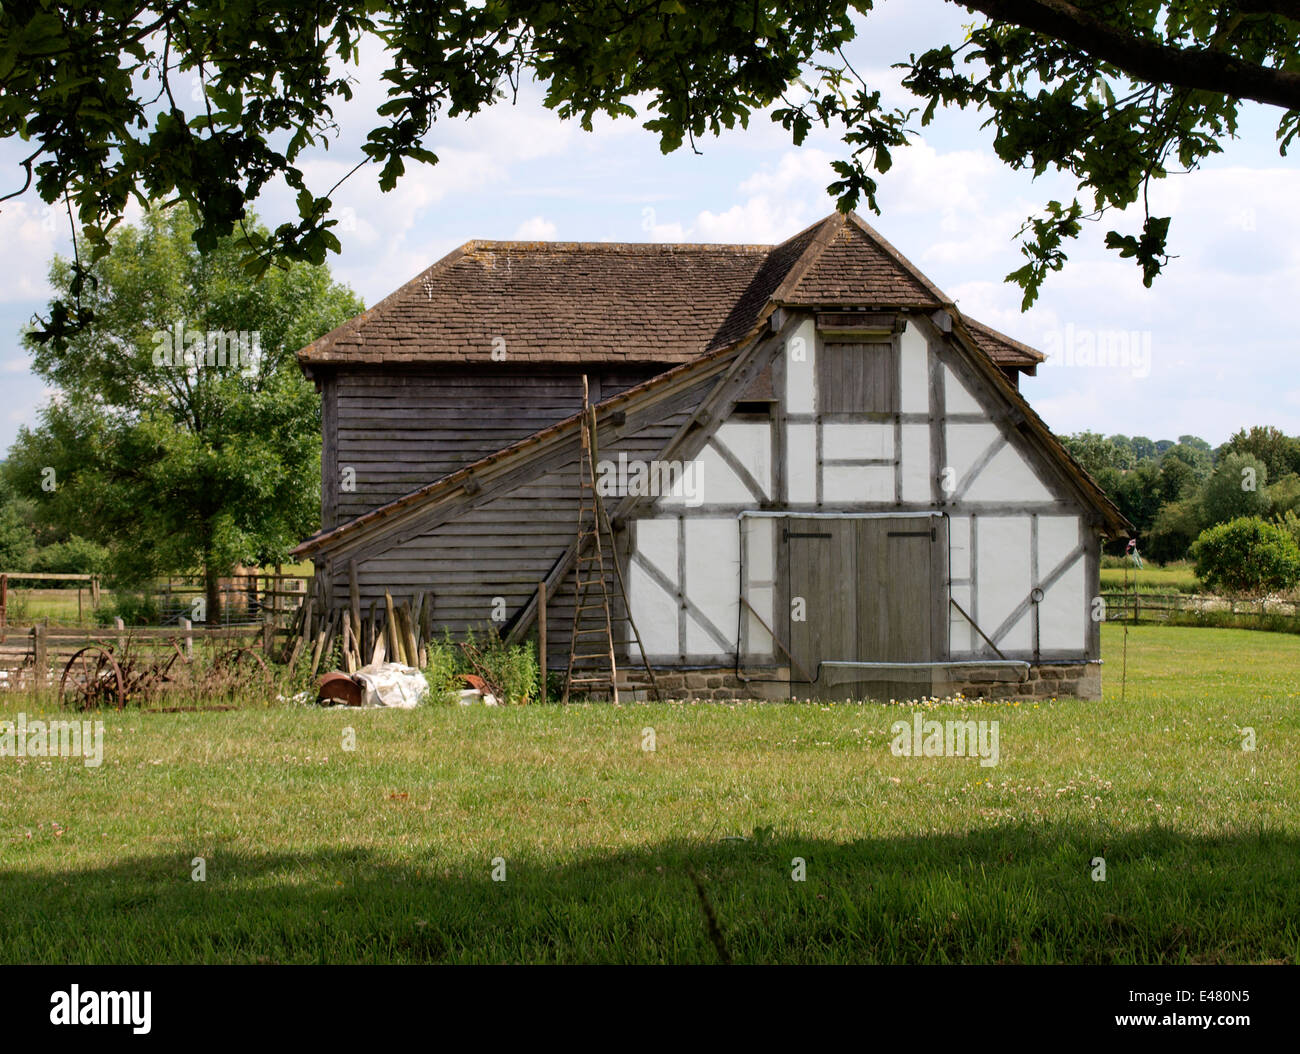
[0,0,1300,456]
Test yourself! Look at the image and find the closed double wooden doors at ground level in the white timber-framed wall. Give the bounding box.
[783,516,946,699]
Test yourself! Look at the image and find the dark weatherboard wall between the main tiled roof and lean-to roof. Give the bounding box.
[321,361,658,529]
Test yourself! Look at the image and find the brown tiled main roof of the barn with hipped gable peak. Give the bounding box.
[298,213,1036,366]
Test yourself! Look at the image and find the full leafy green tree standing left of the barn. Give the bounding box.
[5,201,361,620]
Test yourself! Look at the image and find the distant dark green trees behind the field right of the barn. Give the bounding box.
[1062,425,1300,563]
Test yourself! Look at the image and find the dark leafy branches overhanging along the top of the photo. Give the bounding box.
[0,0,1300,339]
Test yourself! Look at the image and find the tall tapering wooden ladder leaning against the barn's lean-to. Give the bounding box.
[560,374,659,703]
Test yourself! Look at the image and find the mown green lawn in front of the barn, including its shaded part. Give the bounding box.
[0,626,1300,963]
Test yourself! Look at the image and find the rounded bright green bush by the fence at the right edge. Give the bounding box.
[1192,516,1300,595]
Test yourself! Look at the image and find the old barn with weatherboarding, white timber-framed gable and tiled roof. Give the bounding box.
[296,213,1128,699]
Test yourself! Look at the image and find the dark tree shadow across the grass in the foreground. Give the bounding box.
[0,824,1300,963]
